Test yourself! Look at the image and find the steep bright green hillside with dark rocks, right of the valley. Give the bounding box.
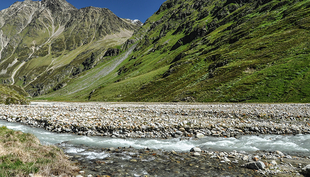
[43,0,310,102]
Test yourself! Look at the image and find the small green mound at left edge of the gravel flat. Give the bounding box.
[0,85,29,104]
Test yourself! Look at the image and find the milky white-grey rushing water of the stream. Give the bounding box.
[0,120,310,158]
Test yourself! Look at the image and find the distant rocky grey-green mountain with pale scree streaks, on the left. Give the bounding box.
[0,0,141,96]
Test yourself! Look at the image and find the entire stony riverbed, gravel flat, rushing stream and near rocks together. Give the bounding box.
[0,103,310,176]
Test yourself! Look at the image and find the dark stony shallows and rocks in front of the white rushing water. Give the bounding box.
[58,143,310,177]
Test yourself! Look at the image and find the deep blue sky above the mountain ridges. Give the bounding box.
[0,0,166,23]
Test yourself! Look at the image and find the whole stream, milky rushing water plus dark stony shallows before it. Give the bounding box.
[0,120,310,176]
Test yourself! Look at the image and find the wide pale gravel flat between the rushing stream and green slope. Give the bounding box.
[0,102,310,140]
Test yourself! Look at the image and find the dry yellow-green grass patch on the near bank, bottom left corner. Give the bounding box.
[0,127,78,177]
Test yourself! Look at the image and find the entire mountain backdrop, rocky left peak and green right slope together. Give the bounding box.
[0,0,310,102]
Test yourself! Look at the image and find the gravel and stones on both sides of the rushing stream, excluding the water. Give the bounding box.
[0,102,310,176]
